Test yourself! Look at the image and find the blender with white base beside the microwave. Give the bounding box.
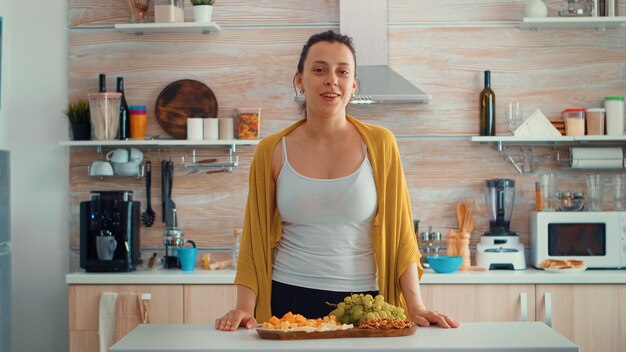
[476,179,526,270]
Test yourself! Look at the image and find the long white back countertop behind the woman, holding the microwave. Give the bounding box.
[65,268,626,285]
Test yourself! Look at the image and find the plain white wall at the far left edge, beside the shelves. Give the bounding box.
[0,0,69,351]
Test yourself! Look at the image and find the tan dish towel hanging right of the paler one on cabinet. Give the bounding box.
[113,292,150,343]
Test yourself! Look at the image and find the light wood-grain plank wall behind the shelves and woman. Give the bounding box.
[68,0,626,270]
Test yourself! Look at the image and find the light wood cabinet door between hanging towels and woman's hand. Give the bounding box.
[184,285,237,324]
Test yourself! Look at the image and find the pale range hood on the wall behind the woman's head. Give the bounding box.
[298,0,431,104]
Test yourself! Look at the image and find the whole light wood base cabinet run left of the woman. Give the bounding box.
[68,285,236,352]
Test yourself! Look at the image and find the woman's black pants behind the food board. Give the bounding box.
[272,281,378,319]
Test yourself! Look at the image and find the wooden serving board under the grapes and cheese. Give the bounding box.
[256,325,417,340]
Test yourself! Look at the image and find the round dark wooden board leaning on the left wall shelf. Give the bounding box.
[154,79,217,139]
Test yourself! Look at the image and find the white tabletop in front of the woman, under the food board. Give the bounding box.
[109,322,578,352]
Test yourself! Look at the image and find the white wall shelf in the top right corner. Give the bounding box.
[519,16,626,32]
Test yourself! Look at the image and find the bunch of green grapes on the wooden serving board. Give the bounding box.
[328,293,406,326]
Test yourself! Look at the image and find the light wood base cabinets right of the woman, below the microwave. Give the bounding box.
[421,284,626,352]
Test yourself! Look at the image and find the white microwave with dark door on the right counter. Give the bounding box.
[530,211,626,269]
